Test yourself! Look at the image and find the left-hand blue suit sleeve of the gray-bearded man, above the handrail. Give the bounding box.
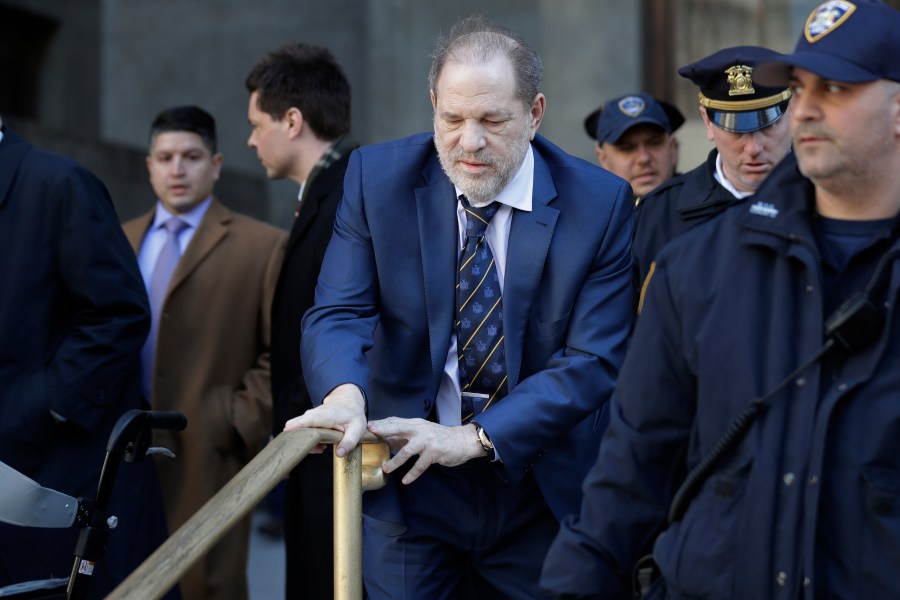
[301,151,378,405]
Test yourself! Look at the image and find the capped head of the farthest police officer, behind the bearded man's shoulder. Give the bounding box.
[584,94,684,206]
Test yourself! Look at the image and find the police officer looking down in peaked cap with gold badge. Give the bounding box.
[632,46,791,304]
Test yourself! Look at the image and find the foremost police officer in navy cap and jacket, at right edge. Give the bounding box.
[541,0,900,600]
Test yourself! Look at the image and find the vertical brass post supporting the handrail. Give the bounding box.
[332,444,363,600]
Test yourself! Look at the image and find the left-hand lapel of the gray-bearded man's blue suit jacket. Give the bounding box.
[416,155,459,382]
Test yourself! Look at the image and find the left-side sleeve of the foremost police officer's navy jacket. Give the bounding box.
[541,248,696,599]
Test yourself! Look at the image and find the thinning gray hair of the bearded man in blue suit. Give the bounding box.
[428,15,544,106]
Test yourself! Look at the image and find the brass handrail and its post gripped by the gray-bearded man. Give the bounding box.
[107,429,389,600]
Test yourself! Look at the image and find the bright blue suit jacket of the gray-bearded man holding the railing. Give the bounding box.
[302,134,633,522]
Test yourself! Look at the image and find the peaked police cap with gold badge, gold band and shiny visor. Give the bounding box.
[678,46,791,133]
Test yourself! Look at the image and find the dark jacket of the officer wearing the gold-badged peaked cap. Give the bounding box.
[631,149,741,291]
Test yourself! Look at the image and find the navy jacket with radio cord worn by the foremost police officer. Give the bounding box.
[542,155,900,599]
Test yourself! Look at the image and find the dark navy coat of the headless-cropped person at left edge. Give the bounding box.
[0,128,165,597]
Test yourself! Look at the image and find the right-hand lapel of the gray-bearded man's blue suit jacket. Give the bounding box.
[503,150,559,390]
